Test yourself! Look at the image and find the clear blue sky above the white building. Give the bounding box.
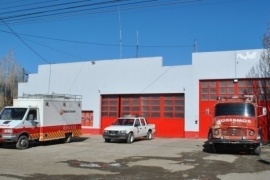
[0,0,270,73]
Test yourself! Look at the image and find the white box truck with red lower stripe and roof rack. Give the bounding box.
[0,94,81,149]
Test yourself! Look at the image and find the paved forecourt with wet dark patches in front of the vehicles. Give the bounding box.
[0,136,270,180]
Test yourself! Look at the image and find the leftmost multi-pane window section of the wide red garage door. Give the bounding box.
[101,96,118,117]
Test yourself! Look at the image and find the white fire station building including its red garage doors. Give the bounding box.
[18,49,268,138]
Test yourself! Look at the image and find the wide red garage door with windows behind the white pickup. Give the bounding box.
[101,94,185,137]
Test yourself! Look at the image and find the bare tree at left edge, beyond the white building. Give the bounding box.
[0,51,24,109]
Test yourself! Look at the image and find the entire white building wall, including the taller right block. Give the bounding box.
[19,50,262,132]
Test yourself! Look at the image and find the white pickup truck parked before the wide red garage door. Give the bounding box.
[103,116,156,143]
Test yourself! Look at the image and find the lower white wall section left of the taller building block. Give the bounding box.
[19,57,197,129]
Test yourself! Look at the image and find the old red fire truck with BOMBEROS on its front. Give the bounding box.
[206,95,267,155]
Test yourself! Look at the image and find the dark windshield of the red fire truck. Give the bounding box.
[215,103,255,117]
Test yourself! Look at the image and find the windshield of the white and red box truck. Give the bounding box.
[0,108,27,120]
